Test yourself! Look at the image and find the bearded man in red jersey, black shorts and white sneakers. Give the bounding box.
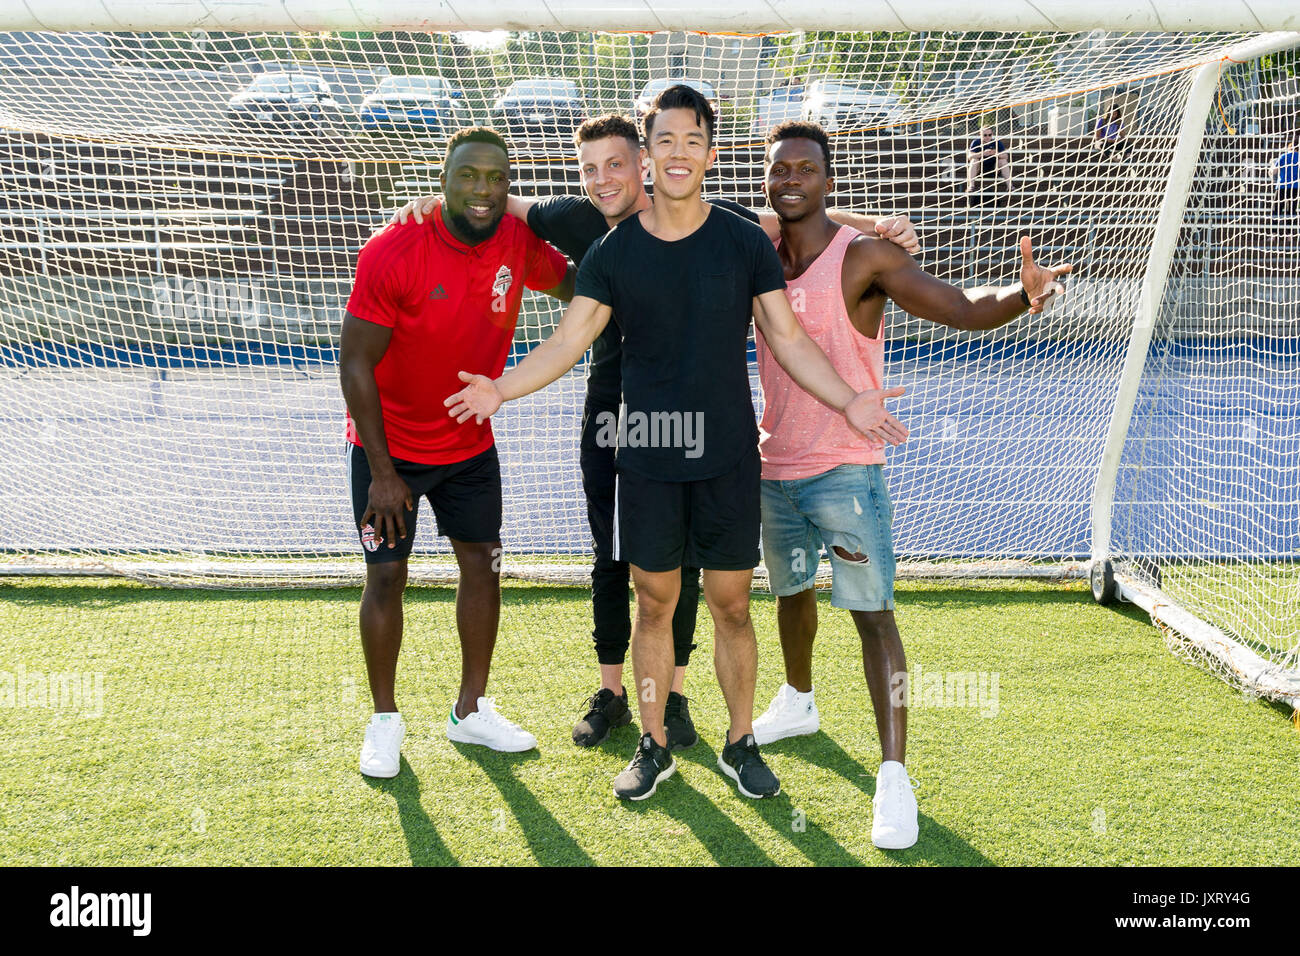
[339,127,573,777]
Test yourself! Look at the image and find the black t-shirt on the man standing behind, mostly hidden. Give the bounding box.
[528,196,758,408]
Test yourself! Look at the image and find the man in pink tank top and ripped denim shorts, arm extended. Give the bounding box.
[754,122,1071,849]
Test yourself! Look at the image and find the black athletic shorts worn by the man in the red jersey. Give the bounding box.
[347,445,501,564]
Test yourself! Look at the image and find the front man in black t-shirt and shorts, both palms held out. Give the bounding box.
[447,86,906,800]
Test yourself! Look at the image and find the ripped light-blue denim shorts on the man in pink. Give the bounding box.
[762,464,894,611]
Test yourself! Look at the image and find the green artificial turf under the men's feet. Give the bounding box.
[0,580,1300,865]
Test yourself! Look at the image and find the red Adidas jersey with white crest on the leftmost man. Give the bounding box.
[347,203,567,464]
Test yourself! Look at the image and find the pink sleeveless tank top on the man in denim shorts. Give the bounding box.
[755,226,885,481]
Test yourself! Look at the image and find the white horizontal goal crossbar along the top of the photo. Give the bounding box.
[0,0,1300,34]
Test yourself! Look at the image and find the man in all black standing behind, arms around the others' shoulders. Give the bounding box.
[395,113,918,749]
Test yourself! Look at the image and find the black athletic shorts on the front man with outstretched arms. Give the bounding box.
[614,446,762,571]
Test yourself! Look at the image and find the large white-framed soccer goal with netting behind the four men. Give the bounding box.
[0,0,1300,704]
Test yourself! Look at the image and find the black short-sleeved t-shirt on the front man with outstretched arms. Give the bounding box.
[573,208,785,481]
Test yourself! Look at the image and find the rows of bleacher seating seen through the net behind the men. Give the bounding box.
[0,135,1300,281]
